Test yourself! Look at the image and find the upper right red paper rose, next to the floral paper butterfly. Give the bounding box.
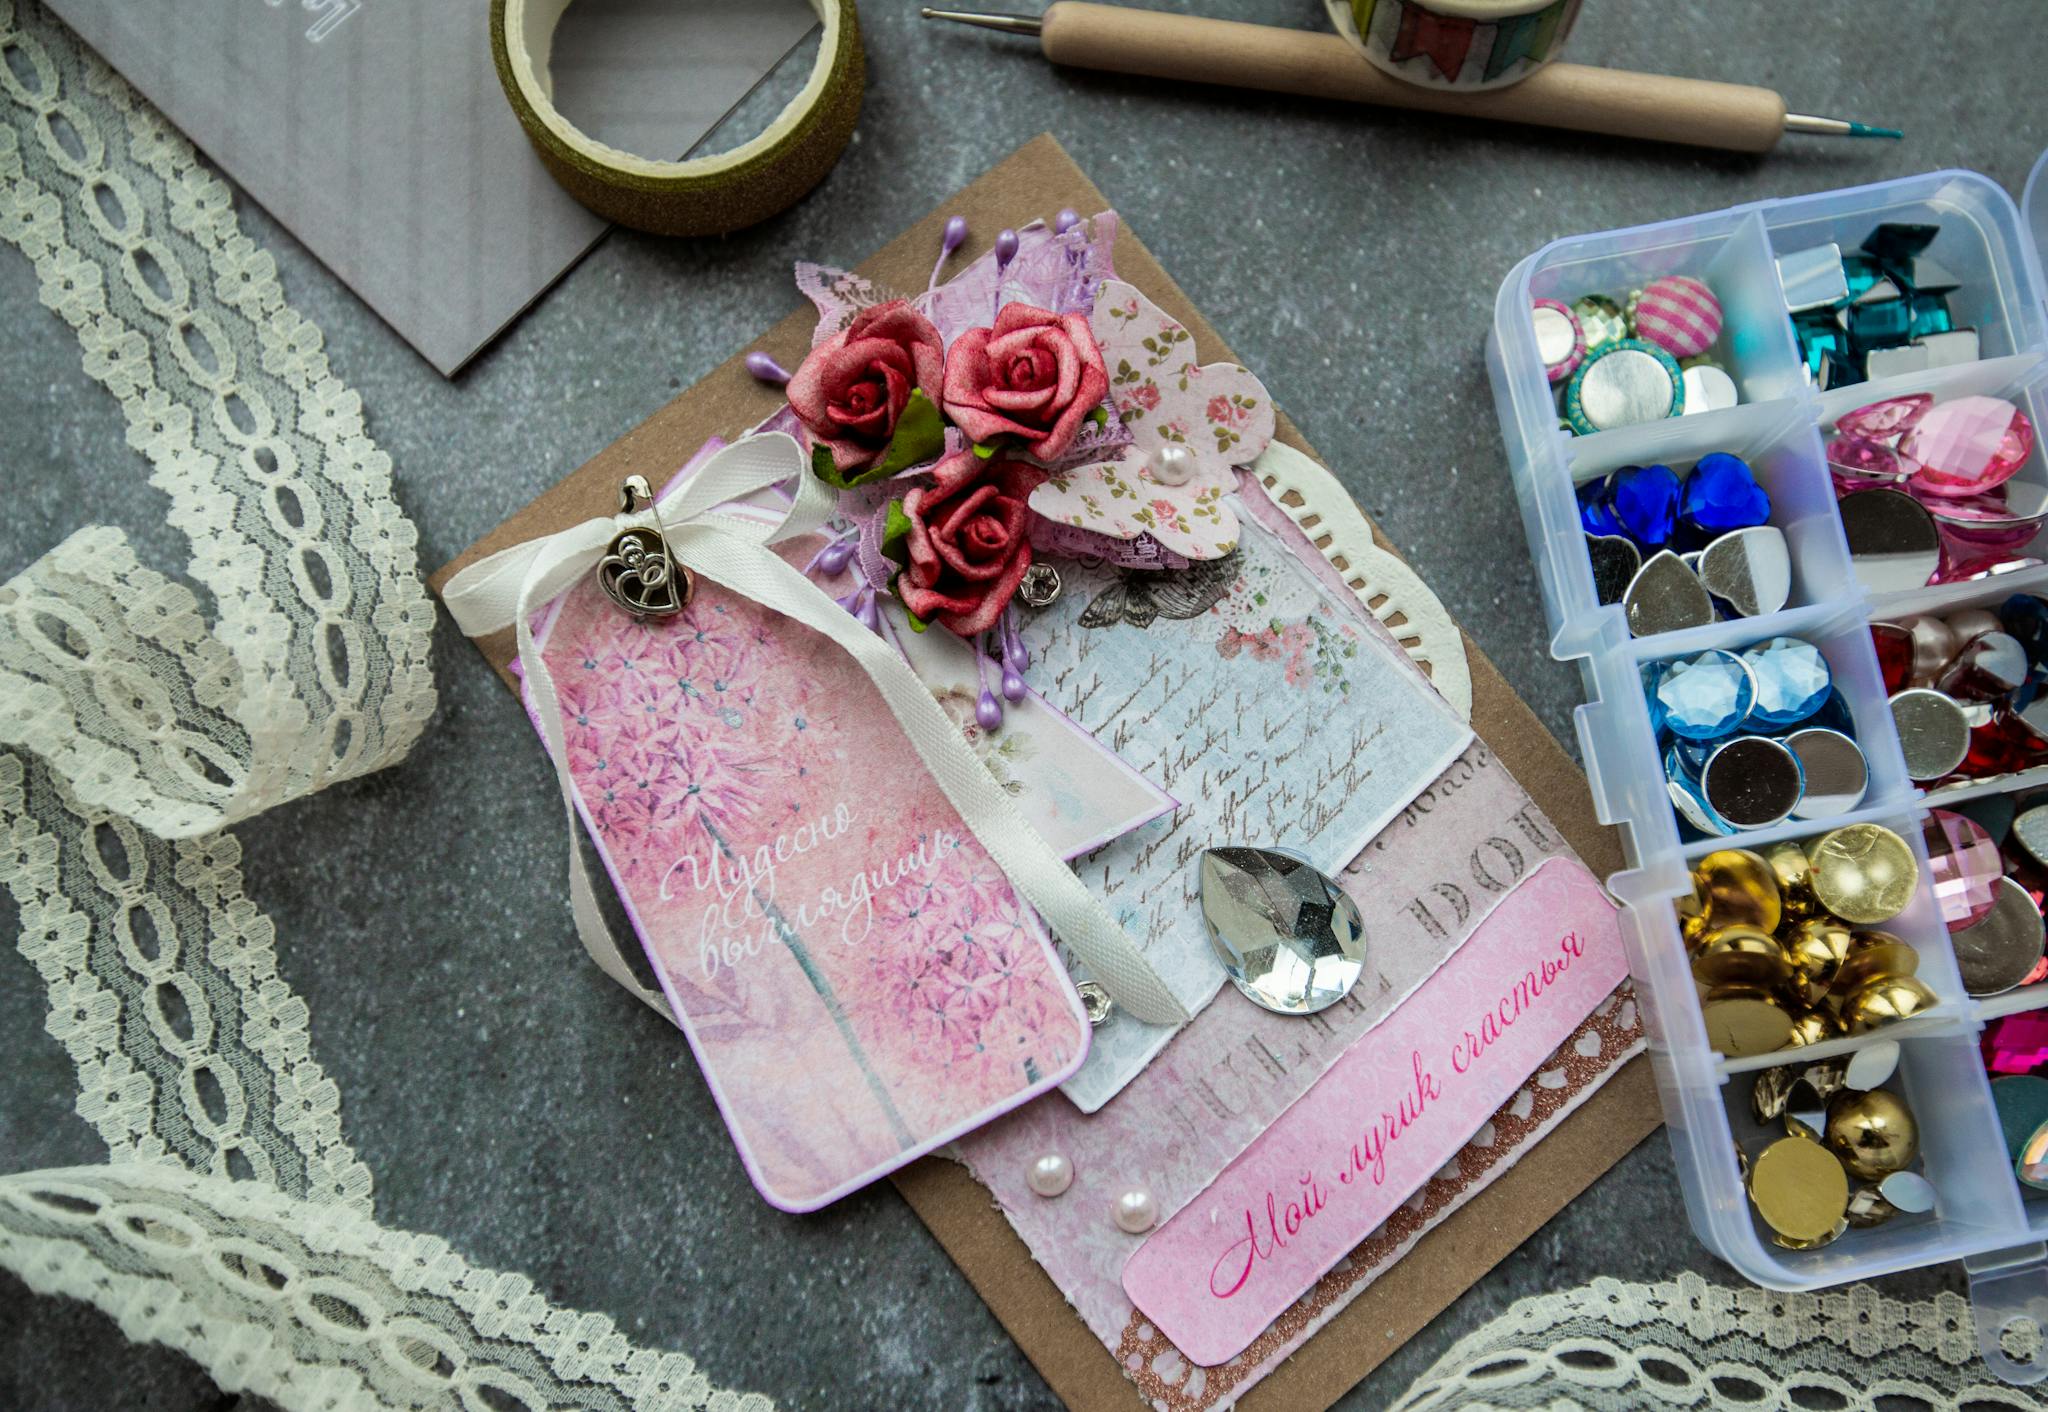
[944,303,1110,461]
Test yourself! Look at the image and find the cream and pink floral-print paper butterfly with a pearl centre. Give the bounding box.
[1032,279,1274,559]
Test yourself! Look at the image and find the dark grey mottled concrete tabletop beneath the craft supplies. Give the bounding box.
[0,0,2048,1412]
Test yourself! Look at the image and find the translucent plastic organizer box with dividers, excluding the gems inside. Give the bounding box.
[1487,156,2048,1383]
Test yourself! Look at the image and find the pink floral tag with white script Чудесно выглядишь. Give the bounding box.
[543,541,1087,1211]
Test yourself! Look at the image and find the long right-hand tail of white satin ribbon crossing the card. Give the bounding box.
[675,521,1188,1025]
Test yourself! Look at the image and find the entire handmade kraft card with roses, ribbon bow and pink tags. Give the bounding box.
[440,139,1655,1412]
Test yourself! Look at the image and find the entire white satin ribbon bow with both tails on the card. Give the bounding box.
[442,432,1188,1025]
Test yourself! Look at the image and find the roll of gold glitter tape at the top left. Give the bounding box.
[492,0,866,236]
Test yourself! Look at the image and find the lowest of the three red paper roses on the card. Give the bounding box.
[897,450,1044,637]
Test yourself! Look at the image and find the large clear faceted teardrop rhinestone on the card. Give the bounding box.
[1202,848,1366,1014]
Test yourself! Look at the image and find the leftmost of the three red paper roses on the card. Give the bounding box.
[788,299,944,480]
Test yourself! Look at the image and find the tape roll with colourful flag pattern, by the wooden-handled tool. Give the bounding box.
[1325,0,1579,92]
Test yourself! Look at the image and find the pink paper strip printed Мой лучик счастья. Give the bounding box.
[1124,859,1628,1367]
